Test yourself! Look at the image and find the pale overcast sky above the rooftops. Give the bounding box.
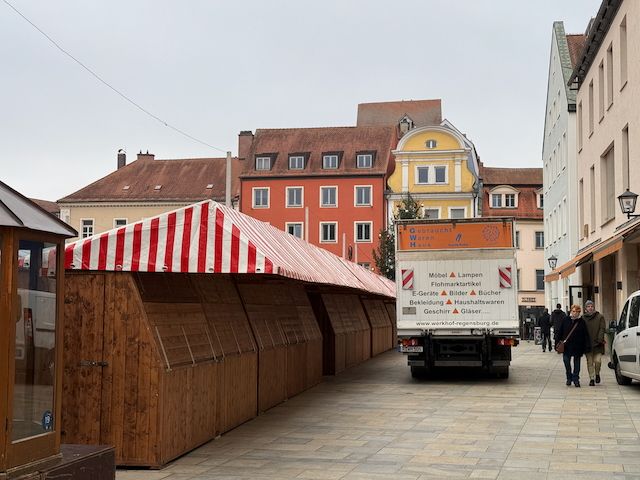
[0,0,600,200]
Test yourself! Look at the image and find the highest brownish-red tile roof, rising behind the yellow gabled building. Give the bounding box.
[357,99,442,127]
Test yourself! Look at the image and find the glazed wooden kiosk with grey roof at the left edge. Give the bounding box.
[0,182,115,479]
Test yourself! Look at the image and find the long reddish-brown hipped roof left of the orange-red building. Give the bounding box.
[58,155,240,202]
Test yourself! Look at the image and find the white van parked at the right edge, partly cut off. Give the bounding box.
[611,290,640,385]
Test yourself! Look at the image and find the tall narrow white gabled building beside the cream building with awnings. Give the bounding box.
[542,22,585,311]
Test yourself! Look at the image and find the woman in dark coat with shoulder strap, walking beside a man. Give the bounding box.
[557,305,591,387]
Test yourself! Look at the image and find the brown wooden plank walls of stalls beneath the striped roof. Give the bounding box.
[62,272,390,467]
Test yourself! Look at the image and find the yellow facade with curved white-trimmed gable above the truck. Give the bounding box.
[387,120,481,222]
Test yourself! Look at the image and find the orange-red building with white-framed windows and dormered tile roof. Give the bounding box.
[238,126,398,268]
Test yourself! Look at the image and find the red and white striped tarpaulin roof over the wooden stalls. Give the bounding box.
[65,200,395,297]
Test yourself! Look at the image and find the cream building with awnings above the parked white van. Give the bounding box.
[556,0,640,320]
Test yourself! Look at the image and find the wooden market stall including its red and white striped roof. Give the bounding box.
[62,201,392,467]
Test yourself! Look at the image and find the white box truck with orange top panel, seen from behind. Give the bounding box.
[396,218,519,378]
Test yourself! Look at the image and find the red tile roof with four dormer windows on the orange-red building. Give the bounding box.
[242,126,397,177]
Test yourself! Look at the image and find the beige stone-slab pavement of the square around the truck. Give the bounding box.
[117,342,640,480]
